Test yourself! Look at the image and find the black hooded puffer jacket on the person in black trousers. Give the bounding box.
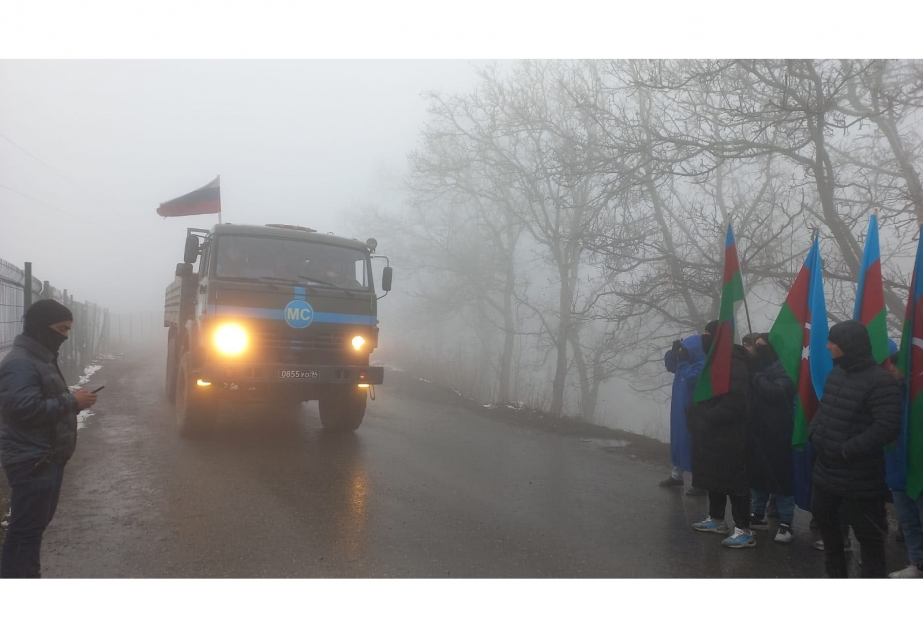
[808,321,901,501]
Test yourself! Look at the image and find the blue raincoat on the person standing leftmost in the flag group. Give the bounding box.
[663,335,705,471]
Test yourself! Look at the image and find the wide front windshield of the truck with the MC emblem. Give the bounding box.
[215,236,369,290]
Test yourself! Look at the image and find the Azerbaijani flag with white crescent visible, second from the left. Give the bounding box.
[769,235,833,447]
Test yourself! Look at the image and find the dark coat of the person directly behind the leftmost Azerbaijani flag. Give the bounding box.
[688,345,750,496]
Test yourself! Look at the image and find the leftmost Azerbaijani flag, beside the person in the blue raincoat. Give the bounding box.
[693,223,744,402]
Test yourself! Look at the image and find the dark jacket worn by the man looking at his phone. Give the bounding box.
[0,335,77,466]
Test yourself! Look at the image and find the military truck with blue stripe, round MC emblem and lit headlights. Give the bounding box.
[164,224,392,436]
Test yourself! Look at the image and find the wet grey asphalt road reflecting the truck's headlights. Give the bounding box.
[42,354,906,578]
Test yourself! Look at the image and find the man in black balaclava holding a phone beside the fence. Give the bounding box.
[0,300,96,578]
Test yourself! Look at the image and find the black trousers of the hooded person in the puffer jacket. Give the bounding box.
[811,486,888,578]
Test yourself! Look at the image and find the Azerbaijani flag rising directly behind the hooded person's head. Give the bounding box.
[853,214,891,367]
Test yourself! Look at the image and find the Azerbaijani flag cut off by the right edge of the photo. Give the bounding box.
[897,228,923,499]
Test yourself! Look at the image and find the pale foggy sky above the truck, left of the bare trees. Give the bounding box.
[0,61,488,312]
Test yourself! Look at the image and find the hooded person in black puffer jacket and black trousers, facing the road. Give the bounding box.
[808,320,901,578]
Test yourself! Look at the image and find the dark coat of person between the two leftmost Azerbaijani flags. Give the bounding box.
[747,361,795,496]
